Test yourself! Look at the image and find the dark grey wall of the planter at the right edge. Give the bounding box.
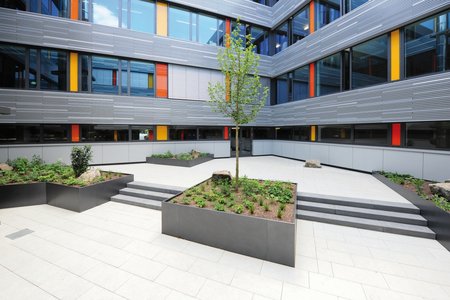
[373,173,450,251]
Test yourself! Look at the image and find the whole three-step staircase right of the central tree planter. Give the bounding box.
[297,193,436,239]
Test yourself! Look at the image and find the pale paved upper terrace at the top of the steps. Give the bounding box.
[99,156,409,203]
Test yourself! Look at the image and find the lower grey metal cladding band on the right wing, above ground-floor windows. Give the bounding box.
[271,72,450,126]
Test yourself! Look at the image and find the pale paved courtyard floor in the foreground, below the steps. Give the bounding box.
[0,202,450,300]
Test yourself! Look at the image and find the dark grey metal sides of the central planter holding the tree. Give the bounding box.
[161,179,297,267]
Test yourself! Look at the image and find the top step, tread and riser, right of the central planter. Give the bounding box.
[297,192,420,214]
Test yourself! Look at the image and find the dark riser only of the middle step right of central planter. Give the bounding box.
[297,204,427,226]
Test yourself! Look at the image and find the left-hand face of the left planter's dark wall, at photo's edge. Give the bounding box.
[0,182,47,209]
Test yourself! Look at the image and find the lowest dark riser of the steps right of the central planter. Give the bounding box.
[297,215,436,239]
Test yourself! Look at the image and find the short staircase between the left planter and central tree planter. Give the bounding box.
[111,181,184,210]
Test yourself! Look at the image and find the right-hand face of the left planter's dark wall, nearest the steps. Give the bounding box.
[47,174,134,212]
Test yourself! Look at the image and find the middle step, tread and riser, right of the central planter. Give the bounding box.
[297,201,428,226]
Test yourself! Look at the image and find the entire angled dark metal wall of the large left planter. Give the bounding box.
[0,174,134,212]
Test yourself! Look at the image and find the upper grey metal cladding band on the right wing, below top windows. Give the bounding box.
[272,0,450,76]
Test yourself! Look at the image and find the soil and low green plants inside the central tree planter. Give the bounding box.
[171,178,297,222]
